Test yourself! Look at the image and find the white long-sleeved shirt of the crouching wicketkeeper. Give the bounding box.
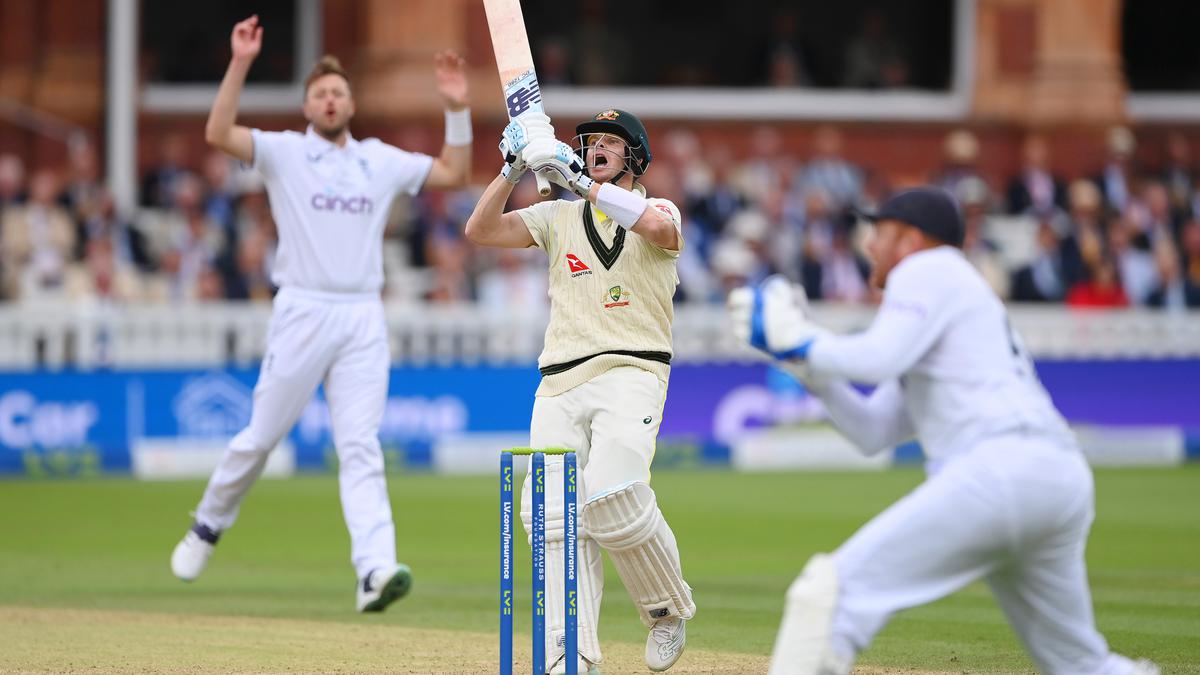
[808,246,1074,462]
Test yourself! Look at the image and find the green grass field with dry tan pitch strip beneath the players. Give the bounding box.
[0,466,1200,675]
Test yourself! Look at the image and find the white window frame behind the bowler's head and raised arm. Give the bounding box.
[140,0,322,114]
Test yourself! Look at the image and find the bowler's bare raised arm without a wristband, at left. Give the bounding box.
[204,14,263,163]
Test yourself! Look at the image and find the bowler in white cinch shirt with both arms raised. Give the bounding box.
[170,17,472,611]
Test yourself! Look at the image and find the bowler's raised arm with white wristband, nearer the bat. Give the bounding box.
[425,52,472,187]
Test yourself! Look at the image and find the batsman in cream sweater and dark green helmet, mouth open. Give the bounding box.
[467,109,696,673]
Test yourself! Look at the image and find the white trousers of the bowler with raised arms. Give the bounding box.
[196,288,396,578]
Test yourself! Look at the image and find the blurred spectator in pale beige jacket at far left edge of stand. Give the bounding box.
[0,169,76,299]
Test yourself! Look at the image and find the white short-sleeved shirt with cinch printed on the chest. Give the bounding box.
[252,126,433,293]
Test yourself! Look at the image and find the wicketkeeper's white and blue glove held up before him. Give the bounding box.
[727,275,826,362]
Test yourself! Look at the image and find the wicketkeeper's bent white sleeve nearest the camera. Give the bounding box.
[808,257,953,384]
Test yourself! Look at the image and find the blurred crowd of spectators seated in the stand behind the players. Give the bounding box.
[0,126,1200,312]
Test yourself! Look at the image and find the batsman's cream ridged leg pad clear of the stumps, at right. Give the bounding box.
[583,480,696,627]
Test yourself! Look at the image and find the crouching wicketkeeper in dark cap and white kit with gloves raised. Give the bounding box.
[730,187,1158,675]
